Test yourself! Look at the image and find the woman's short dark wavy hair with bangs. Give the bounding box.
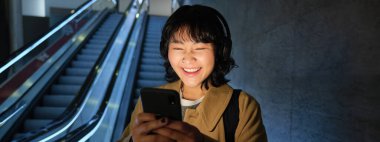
[160,5,236,89]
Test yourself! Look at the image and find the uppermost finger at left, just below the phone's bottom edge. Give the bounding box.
[134,117,169,135]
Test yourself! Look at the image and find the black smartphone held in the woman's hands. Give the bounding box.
[140,88,182,121]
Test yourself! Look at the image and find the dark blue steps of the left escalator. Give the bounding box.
[13,13,123,139]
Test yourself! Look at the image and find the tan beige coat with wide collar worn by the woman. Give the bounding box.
[122,81,267,142]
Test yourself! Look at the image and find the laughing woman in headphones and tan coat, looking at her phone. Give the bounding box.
[122,5,267,142]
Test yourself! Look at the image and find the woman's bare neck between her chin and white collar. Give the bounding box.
[182,85,206,100]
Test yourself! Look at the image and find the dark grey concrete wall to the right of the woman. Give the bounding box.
[185,0,380,142]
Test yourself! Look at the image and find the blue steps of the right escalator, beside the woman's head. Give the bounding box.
[134,15,167,103]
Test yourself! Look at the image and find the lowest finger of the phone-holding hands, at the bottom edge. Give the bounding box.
[153,127,189,141]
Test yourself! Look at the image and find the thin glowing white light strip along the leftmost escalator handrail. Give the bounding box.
[0,0,97,74]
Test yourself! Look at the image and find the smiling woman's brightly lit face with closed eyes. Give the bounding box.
[168,32,215,88]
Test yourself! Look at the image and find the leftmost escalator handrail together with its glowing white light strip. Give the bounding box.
[0,0,97,74]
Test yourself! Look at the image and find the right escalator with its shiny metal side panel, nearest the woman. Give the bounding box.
[29,14,171,141]
